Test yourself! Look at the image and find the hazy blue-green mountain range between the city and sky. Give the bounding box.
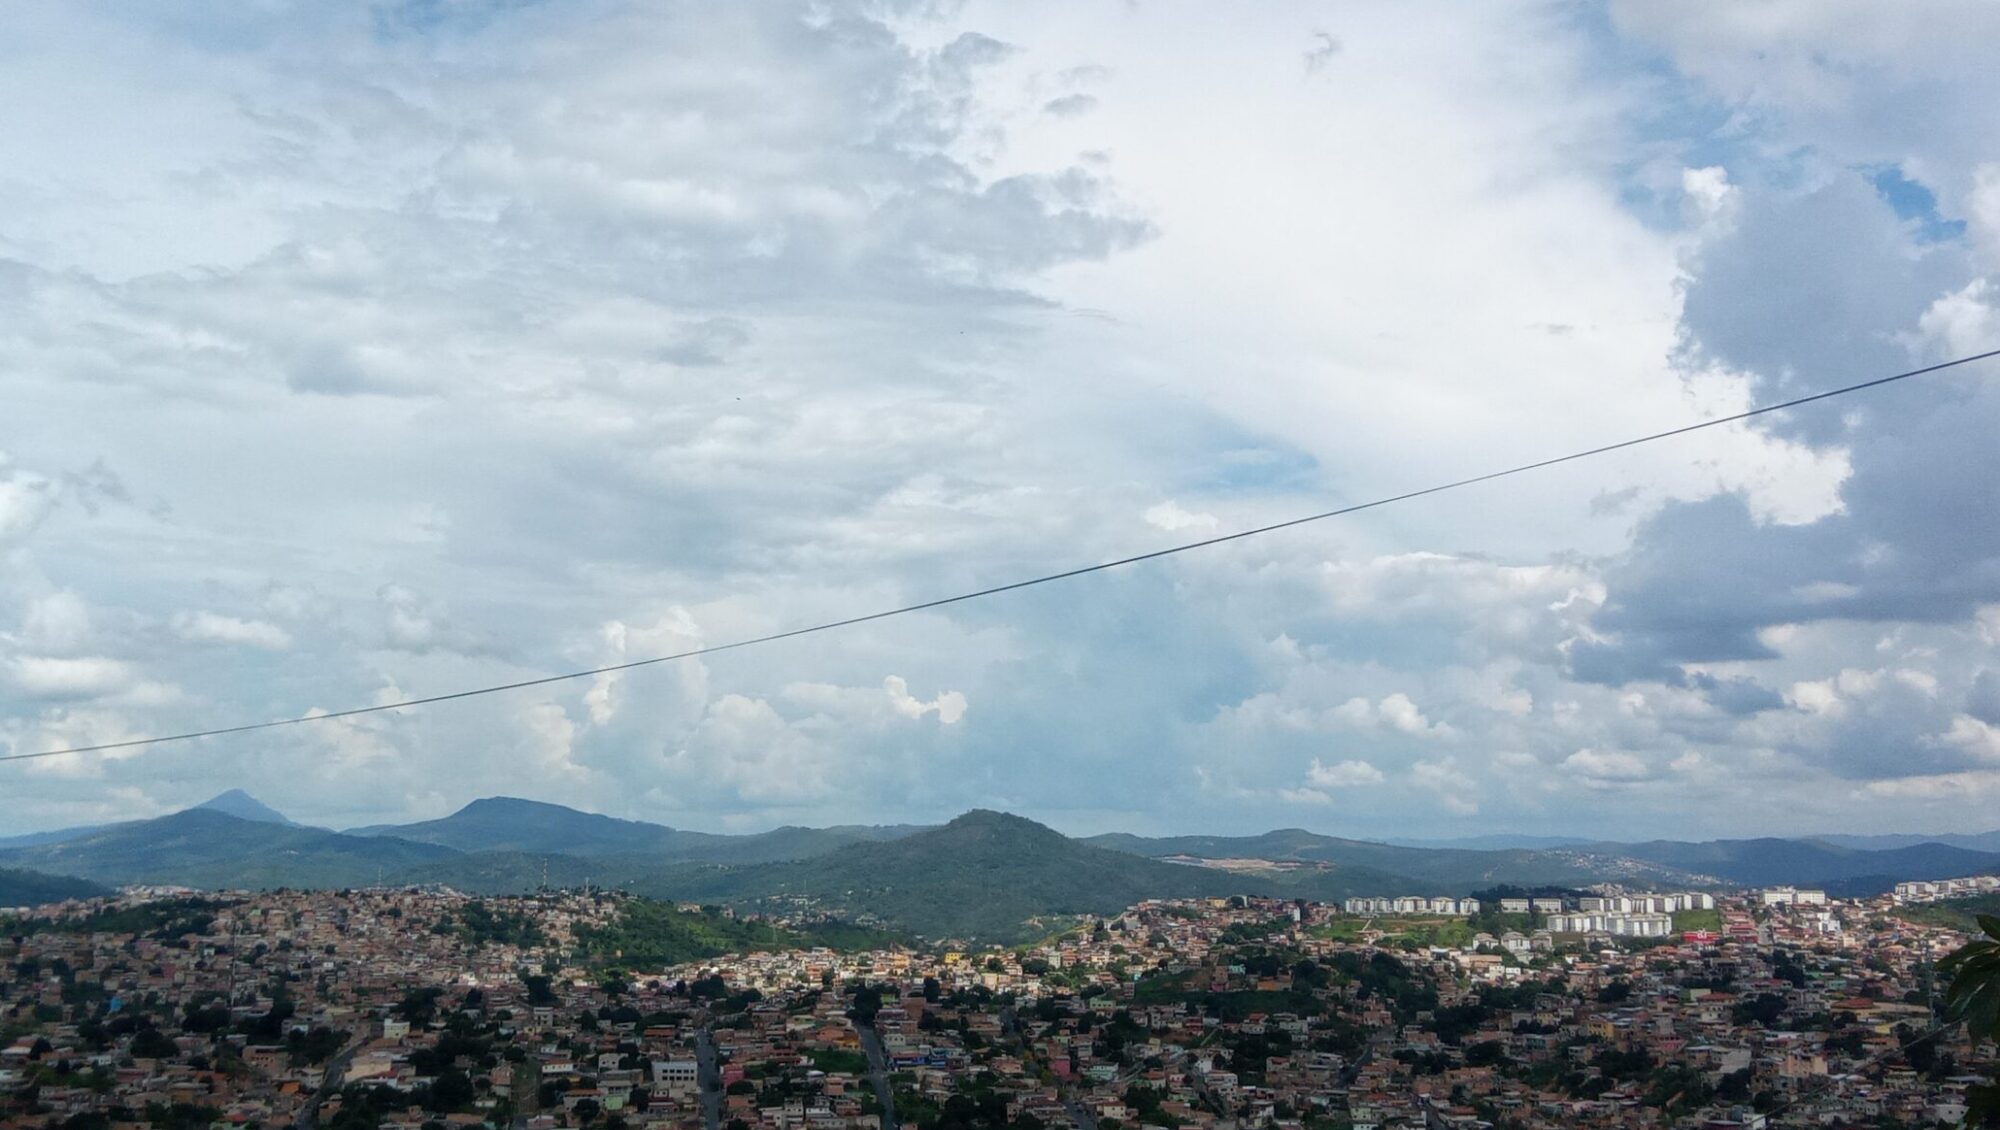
[0,790,2000,938]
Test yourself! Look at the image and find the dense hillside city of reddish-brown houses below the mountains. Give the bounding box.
[0,888,1994,1130]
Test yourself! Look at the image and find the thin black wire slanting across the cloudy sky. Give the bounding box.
[0,350,2000,762]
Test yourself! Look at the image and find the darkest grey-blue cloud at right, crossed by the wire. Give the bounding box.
[1570,174,2000,692]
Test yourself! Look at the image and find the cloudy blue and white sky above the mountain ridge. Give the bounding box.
[0,0,2000,838]
